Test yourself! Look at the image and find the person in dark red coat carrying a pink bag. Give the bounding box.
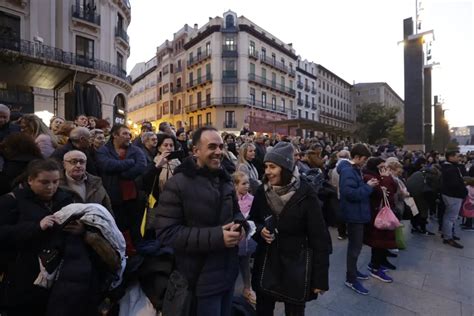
[363,157,397,283]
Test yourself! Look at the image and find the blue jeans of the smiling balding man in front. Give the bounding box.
[197,288,234,316]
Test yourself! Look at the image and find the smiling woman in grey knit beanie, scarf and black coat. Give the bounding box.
[249,142,330,316]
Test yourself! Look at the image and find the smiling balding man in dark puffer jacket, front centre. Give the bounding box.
[156,127,245,316]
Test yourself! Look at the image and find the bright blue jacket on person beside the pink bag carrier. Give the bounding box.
[337,160,372,224]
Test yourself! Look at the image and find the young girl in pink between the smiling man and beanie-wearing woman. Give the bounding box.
[233,171,257,304]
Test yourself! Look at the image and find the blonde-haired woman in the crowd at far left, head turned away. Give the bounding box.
[20,114,58,158]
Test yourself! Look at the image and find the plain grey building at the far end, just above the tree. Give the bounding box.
[352,82,405,123]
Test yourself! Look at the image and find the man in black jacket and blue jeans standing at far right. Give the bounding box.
[441,151,467,248]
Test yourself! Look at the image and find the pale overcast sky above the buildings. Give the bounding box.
[127,0,474,126]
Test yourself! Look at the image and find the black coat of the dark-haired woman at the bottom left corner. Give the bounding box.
[0,188,72,307]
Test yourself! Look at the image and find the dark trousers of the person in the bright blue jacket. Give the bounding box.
[346,223,364,283]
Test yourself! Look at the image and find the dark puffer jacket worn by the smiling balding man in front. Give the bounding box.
[155,157,243,296]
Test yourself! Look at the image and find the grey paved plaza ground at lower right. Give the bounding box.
[238,221,474,316]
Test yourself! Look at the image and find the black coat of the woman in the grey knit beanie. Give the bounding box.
[249,181,331,298]
